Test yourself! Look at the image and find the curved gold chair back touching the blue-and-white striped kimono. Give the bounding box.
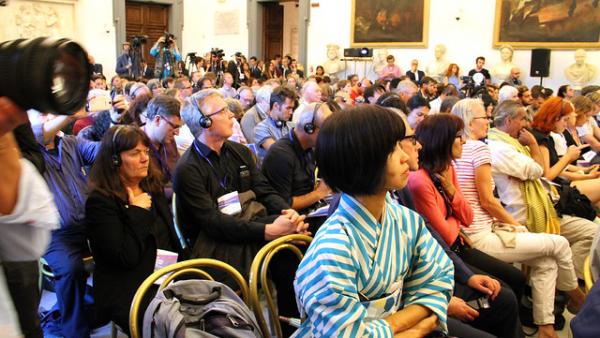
[250,234,312,338]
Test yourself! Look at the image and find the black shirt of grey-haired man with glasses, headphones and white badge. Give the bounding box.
[173,140,290,280]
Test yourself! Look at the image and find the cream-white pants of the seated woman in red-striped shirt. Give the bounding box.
[469,227,580,325]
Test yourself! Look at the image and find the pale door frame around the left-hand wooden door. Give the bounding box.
[113,0,184,55]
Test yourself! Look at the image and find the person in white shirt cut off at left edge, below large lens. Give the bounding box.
[0,97,59,337]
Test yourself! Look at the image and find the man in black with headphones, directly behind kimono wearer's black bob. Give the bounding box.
[261,103,331,213]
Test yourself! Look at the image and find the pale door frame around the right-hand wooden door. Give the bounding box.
[247,0,310,67]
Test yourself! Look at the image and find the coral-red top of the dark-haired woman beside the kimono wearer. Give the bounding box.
[408,166,473,245]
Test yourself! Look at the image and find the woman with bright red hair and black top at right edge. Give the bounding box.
[531,97,600,203]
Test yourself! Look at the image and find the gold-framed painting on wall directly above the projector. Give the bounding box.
[350,0,429,47]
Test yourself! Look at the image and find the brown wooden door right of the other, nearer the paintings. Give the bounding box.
[262,2,283,62]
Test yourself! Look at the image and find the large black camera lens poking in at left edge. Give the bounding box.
[0,38,92,115]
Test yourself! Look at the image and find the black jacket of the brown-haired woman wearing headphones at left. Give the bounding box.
[85,191,178,328]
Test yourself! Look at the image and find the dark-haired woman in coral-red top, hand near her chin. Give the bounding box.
[408,114,525,299]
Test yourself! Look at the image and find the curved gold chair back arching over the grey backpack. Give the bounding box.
[129,258,250,338]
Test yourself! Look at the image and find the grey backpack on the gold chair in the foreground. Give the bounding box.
[142,280,262,338]
